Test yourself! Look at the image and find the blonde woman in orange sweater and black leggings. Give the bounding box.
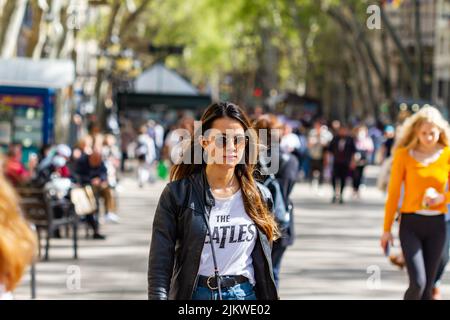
[381,107,450,300]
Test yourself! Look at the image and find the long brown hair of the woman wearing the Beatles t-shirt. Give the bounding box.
[170,102,279,241]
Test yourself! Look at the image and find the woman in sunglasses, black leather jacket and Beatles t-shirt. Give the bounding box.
[148,103,278,300]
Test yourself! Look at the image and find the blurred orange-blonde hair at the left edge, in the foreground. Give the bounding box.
[0,172,37,291]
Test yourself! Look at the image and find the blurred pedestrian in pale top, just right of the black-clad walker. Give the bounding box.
[352,126,374,198]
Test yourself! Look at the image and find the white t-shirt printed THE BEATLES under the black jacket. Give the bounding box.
[198,190,258,285]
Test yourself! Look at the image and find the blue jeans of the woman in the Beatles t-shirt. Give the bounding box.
[192,281,256,300]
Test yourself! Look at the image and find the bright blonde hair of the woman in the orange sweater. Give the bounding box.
[394,106,450,149]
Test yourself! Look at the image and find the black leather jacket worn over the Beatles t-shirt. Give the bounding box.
[148,170,278,300]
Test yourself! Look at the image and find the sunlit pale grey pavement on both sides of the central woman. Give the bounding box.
[16,168,450,300]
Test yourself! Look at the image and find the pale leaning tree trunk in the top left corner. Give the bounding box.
[1,0,28,59]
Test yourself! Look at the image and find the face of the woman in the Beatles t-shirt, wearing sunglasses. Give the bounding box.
[201,118,246,167]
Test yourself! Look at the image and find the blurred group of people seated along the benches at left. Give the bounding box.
[3,125,125,239]
